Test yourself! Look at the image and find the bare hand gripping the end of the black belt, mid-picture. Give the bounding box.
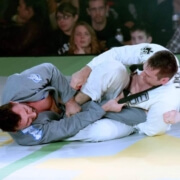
[102,99,125,112]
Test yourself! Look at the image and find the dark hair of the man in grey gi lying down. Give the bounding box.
[0,103,21,132]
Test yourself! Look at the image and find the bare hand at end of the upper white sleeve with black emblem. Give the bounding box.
[70,66,91,90]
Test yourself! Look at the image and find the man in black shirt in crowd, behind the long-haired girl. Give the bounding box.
[87,0,117,50]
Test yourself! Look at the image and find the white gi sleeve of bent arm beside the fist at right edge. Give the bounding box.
[135,88,180,136]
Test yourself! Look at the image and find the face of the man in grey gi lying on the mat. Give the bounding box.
[12,102,38,130]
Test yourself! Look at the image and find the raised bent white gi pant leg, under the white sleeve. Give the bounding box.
[81,60,129,102]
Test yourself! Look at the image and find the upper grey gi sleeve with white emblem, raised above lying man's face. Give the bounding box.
[2,63,76,104]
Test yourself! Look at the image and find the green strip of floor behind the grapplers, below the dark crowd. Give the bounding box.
[0,54,180,76]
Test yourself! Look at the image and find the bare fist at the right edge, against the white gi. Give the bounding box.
[163,110,180,124]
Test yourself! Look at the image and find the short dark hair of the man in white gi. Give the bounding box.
[147,50,178,79]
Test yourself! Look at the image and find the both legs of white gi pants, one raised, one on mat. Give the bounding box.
[66,60,134,142]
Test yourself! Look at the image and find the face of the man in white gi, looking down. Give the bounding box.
[141,63,163,86]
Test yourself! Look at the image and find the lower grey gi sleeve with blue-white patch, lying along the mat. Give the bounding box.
[10,102,105,145]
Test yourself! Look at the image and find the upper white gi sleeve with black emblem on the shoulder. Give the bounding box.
[87,43,167,69]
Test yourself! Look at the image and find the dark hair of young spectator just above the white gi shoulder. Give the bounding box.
[130,22,152,36]
